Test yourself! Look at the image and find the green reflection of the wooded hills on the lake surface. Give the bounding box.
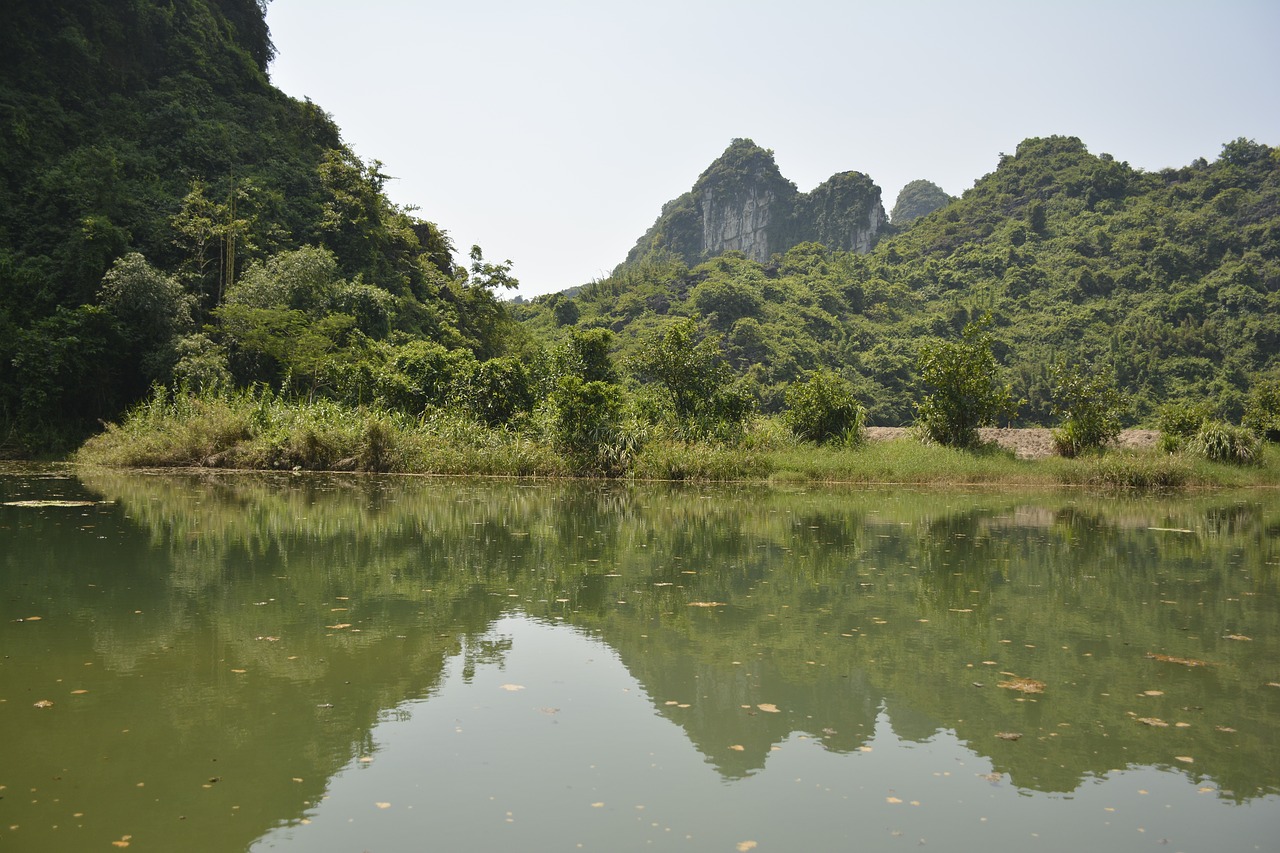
[3,473,1280,847]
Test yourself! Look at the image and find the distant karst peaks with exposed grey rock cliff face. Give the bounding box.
[626,140,886,265]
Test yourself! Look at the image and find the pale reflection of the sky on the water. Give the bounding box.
[255,616,1280,850]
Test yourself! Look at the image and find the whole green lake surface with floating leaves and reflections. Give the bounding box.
[0,467,1280,853]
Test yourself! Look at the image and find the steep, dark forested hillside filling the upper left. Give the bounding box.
[0,0,512,453]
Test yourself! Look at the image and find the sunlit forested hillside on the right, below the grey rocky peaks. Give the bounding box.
[520,137,1280,425]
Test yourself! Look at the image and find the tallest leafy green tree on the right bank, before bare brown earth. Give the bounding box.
[916,315,1016,448]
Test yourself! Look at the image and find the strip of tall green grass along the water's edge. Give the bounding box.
[76,392,1280,491]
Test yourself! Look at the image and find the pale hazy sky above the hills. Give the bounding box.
[268,0,1280,298]
